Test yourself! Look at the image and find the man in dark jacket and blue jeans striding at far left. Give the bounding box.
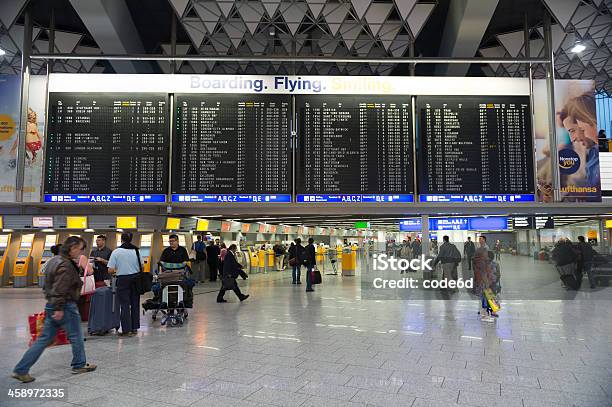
[13,236,96,383]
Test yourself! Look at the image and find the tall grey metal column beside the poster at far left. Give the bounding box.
[15,8,32,202]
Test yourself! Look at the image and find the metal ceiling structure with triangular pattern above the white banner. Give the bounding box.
[0,0,612,93]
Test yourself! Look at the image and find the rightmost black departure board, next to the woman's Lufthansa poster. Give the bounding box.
[417,96,535,202]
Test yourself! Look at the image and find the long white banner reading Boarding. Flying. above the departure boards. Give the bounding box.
[49,73,529,96]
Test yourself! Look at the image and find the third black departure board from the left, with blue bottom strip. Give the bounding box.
[296,95,414,202]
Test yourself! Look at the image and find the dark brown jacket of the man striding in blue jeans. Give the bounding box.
[45,256,83,310]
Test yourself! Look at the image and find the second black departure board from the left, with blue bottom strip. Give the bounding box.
[171,94,292,202]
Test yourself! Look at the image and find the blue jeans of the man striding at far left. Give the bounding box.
[13,302,86,374]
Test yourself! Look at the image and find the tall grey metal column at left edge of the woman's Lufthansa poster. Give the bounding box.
[544,12,561,202]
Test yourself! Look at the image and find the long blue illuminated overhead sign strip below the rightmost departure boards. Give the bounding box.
[399,216,508,232]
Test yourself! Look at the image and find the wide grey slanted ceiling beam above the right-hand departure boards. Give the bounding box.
[436,0,499,76]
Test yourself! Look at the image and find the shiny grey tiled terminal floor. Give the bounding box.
[0,256,612,407]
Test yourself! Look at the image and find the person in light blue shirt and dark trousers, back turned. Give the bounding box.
[108,232,144,337]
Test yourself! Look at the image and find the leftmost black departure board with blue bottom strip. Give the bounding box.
[44,93,169,202]
